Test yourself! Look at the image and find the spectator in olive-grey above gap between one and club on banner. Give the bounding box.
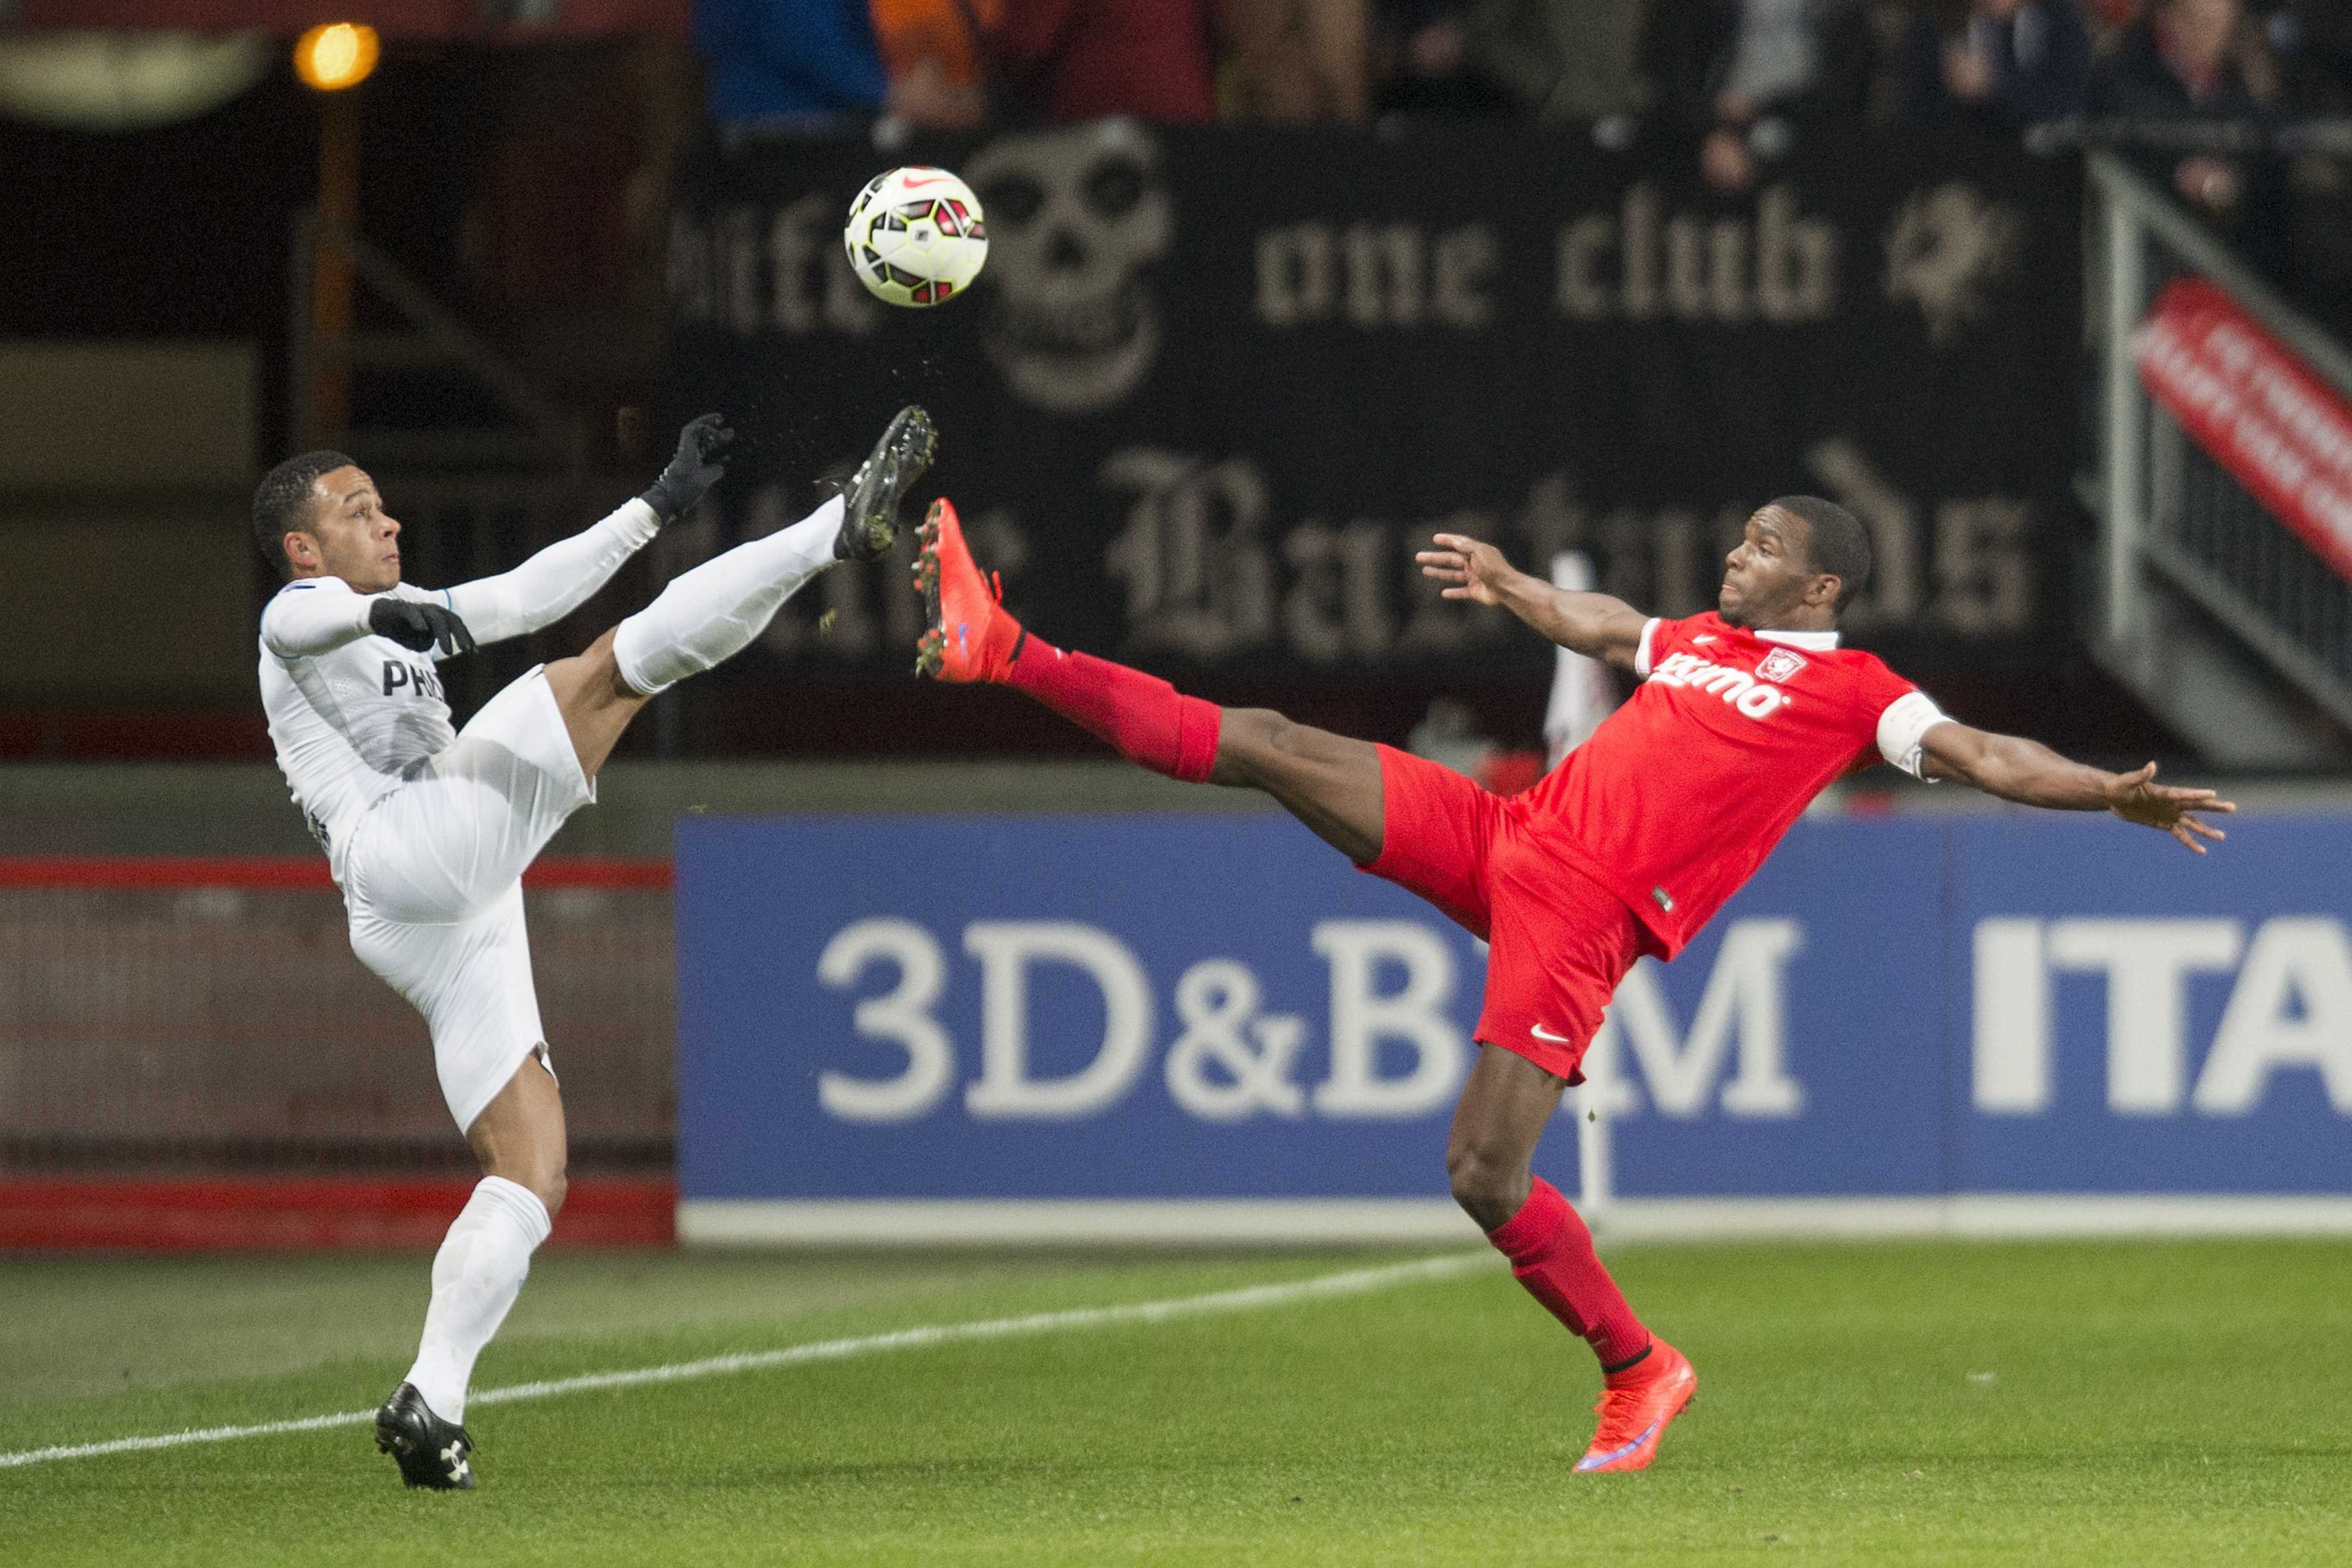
[1468,0,1672,120]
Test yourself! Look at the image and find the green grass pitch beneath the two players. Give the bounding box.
[0,1241,2352,1568]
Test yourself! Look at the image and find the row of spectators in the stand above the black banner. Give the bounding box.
[694,0,2352,319]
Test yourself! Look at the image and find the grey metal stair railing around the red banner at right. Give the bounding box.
[2086,153,2352,764]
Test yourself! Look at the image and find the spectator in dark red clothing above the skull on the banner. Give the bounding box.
[992,0,1216,120]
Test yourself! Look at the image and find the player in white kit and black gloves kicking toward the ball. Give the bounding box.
[254,409,934,1490]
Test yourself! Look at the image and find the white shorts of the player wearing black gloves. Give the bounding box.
[343,668,595,1131]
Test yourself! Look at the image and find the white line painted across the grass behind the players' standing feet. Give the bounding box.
[0,1251,1494,1469]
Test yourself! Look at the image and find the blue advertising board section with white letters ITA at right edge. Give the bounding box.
[1945,816,2352,1194]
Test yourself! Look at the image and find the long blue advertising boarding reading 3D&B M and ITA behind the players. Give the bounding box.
[677,813,2352,1239]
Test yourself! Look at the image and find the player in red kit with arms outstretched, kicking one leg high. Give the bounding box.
[915,496,2232,1472]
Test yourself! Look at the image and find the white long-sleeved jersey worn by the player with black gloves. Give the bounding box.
[261,501,661,882]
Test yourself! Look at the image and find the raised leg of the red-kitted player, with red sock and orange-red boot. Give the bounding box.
[915,501,1381,865]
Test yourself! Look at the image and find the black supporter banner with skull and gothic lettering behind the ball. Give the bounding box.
[663,122,2082,684]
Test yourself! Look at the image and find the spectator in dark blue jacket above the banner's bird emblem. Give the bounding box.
[1903,0,2091,131]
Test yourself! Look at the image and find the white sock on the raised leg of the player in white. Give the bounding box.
[611,496,842,696]
